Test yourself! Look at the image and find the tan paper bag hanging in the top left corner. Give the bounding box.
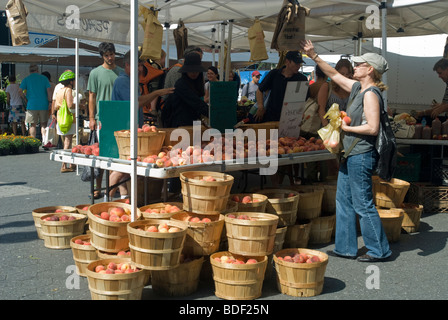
[6,0,30,46]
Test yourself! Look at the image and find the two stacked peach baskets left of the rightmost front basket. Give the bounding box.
[210,212,278,300]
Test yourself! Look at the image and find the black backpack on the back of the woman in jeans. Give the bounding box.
[371,88,397,181]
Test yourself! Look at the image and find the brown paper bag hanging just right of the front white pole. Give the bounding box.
[140,7,163,60]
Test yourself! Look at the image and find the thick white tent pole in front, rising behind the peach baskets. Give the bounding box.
[130,0,138,221]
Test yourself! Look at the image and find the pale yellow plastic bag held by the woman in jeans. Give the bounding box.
[317,103,342,153]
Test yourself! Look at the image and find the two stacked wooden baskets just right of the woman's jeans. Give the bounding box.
[372,176,412,242]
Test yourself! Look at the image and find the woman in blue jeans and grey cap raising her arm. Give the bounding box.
[302,40,392,262]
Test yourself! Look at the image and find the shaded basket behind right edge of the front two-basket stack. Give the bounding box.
[257,189,299,227]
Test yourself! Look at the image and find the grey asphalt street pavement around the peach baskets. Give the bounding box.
[0,150,448,304]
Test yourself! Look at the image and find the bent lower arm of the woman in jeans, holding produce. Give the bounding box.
[341,91,380,136]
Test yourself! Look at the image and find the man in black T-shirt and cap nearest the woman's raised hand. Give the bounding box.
[255,51,308,122]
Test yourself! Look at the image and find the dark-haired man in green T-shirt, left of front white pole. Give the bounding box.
[87,42,124,199]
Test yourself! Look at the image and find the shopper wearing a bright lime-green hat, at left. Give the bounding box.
[52,71,76,173]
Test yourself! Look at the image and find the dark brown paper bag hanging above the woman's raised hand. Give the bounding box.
[271,0,310,51]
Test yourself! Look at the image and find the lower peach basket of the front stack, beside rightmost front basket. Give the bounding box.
[210,251,268,300]
